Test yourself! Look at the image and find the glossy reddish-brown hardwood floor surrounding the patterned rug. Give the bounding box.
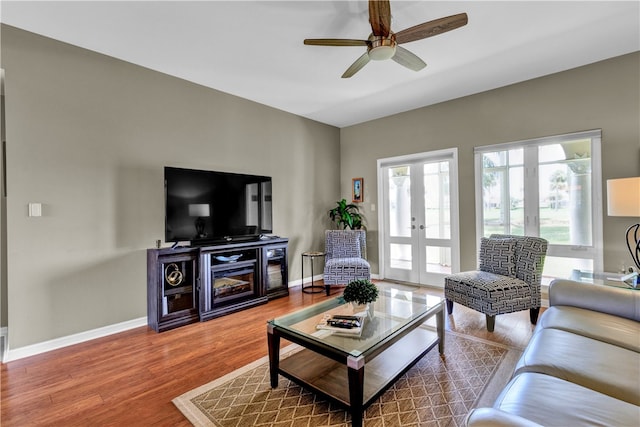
[0,287,532,427]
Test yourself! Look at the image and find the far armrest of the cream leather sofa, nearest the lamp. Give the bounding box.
[549,279,640,321]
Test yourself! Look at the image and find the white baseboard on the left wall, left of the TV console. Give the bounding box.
[2,317,147,363]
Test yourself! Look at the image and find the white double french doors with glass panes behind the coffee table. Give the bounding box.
[378,149,460,286]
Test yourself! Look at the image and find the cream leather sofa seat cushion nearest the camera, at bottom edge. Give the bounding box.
[488,373,640,426]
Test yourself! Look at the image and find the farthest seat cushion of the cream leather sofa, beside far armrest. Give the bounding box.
[536,305,640,353]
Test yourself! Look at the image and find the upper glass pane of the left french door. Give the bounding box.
[388,166,411,237]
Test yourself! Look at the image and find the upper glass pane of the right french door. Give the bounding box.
[424,161,451,239]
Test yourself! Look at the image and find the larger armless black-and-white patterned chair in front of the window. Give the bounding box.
[444,234,548,332]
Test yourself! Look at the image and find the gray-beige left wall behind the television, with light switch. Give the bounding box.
[2,26,340,349]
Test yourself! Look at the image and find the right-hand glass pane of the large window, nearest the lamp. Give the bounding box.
[538,140,593,246]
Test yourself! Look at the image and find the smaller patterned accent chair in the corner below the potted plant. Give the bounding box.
[324,230,371,295]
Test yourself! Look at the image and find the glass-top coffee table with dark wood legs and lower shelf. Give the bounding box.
[267,289,444,427]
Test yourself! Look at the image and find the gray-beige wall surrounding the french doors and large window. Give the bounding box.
[340,52,640,271]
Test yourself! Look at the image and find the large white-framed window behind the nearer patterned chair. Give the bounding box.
[475,130,602,278]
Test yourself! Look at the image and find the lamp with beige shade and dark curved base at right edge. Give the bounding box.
[607,176,640,272]
